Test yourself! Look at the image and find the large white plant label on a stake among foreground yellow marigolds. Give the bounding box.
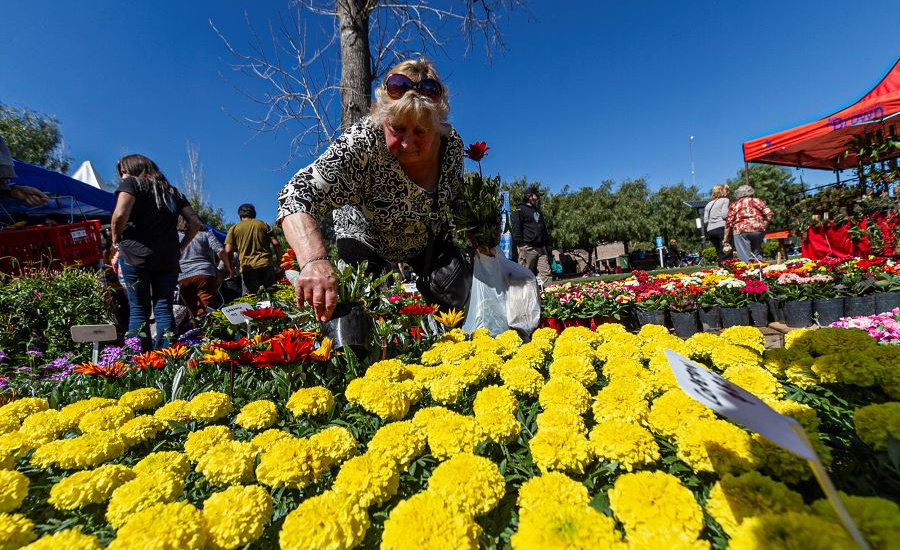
[665,349,869,550]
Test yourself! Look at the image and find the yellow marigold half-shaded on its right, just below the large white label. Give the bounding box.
[675,418,764,474]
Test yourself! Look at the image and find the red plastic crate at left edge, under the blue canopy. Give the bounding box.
[0,220,103,273]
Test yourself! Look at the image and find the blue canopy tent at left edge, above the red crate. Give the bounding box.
[0,160,116,223]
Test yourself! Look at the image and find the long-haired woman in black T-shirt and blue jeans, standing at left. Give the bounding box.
[110,155,202,351]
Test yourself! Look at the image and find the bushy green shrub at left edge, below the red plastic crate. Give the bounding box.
[0,267,113,370]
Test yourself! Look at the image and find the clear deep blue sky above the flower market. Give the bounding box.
[0,0,900,221]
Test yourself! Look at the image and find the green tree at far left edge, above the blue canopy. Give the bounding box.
[0,103,71,172]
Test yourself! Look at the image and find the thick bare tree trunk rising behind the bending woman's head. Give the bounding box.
[337,0,372,131]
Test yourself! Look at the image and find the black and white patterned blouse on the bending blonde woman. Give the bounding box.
[278,117,463,262]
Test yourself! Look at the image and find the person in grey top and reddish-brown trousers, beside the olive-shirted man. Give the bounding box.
[178,218,233,318]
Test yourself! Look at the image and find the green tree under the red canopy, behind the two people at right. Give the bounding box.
[725,164,806,229]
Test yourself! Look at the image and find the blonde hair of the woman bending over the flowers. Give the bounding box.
[369,58,450,136]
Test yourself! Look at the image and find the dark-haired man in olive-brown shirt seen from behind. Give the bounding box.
[225,203,282,294]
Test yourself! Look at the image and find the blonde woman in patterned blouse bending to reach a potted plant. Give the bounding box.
[278,59,463,321]
